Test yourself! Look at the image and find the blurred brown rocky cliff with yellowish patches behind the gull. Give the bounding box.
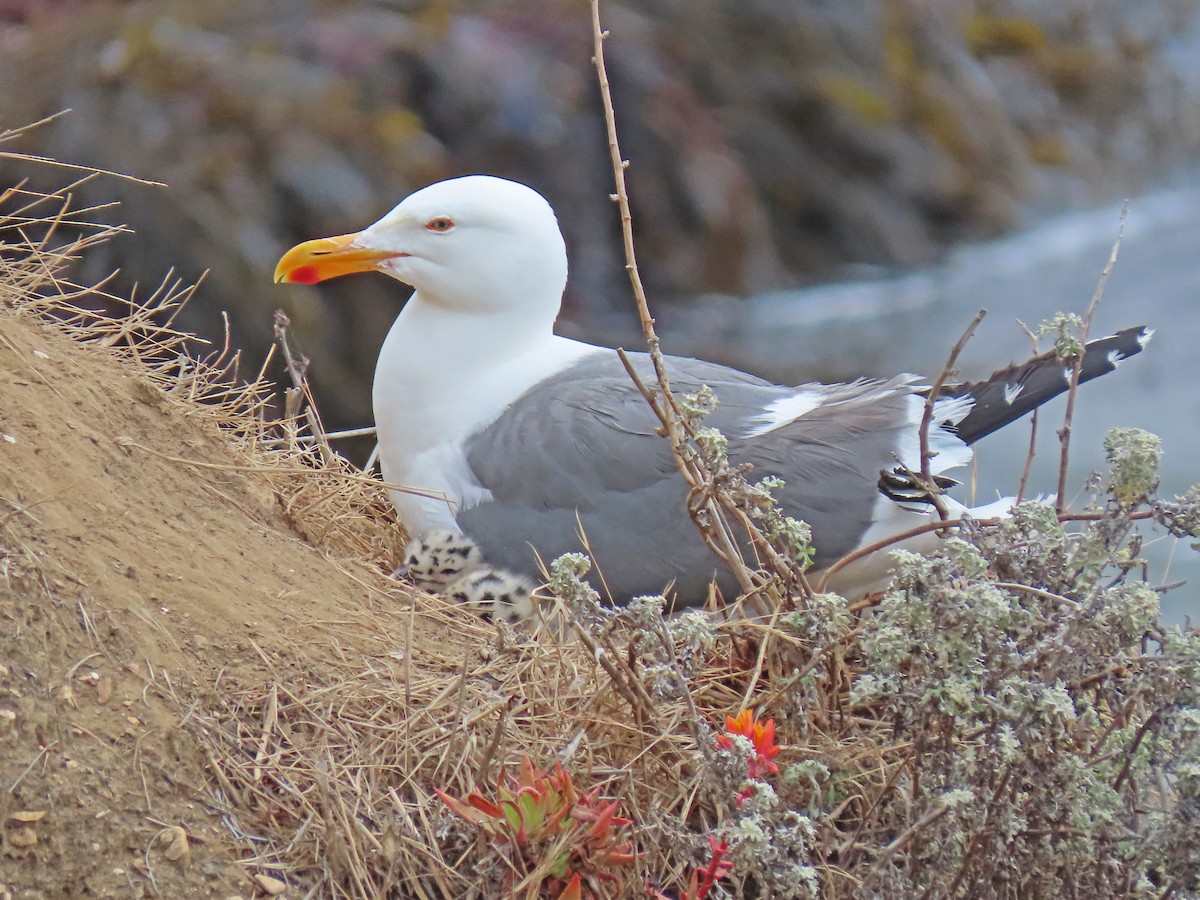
[0,0,1200,426]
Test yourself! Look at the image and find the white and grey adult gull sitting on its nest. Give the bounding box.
[275,175,1152,608]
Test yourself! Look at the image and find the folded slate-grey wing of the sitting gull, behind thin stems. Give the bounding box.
[457,353,911,606]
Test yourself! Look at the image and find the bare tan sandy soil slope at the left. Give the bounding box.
[0,310,412,900]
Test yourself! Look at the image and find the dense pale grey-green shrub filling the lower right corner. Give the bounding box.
[827,430,1200,898]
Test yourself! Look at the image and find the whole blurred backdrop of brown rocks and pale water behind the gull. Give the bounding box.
[0,0,1200,618]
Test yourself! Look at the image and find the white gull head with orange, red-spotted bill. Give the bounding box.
[275,175,566,322]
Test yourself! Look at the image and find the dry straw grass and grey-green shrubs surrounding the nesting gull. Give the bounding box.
[0,121,1200,898]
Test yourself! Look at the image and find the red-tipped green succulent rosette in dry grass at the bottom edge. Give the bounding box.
[437,757,637,900]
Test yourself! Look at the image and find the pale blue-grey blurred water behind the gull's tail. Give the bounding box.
[662,185,1200,622]
